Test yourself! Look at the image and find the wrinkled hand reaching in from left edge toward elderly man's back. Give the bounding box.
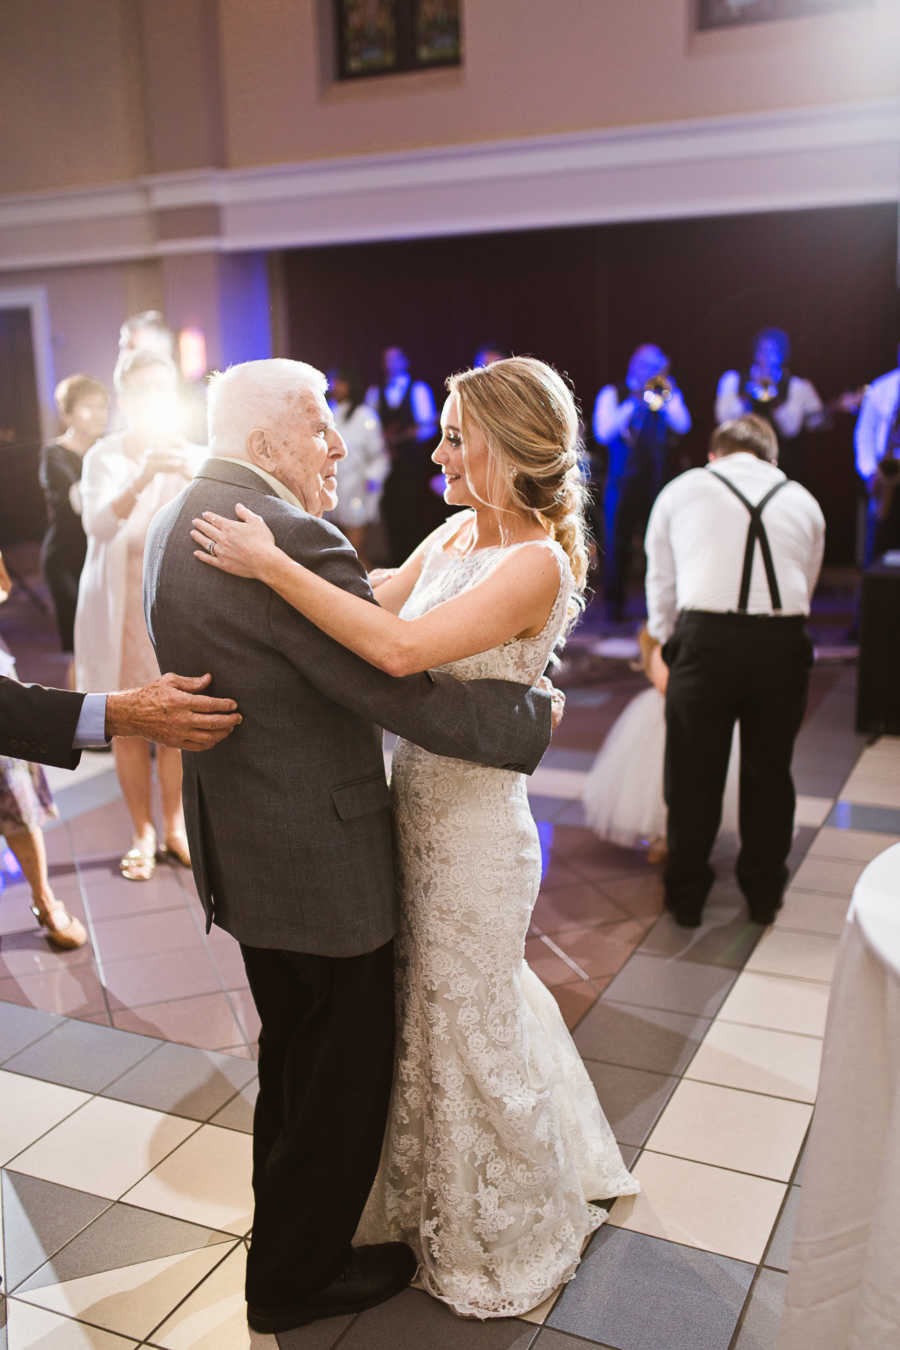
[107,674,243,751]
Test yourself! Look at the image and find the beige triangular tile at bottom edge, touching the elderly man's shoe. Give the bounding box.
[151,1242,278,1350]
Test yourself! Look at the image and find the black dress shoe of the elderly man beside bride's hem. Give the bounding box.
[247,1242,416,1335]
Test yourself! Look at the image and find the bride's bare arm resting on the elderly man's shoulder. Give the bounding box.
[192,505,560,676]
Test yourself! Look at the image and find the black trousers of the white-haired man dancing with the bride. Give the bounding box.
[240,942,394,1308]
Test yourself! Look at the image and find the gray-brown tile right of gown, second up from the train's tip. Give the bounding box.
[575,999,710,1075]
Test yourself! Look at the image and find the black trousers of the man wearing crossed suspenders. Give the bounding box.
[663,610,812,911]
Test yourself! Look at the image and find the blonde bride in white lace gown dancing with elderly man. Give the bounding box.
[192,358,638,1318]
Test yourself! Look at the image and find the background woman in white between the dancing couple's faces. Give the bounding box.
[328,369,390,566]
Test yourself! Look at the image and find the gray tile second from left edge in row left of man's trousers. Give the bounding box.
[4,1018,159,1092]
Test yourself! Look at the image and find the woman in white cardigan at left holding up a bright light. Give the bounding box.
[74,350,202,882]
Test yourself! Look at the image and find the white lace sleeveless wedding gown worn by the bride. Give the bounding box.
[358,516,640,1318]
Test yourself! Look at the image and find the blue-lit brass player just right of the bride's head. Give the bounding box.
[594,343,691,624]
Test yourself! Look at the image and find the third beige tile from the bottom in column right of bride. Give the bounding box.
[685,1021,822,1102]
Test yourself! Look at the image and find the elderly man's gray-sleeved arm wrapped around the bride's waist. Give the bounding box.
[269,517,551,774]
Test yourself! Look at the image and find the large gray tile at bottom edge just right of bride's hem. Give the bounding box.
[550,1227,754,1350]
